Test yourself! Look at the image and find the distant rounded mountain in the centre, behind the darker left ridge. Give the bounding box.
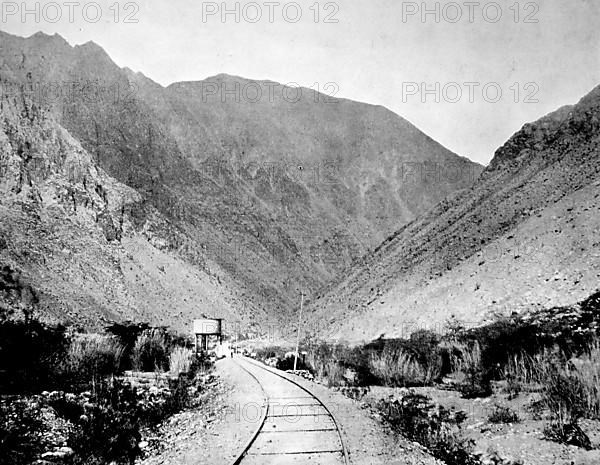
[161,75,480,246]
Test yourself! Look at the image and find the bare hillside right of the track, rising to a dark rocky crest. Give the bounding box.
[311,87,600,341]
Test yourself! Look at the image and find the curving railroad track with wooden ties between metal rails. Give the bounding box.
[233,358,349,465]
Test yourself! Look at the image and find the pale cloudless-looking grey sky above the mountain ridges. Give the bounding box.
[0,0,600,164]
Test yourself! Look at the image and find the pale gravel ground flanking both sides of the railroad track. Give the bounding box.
[141,359,441,465]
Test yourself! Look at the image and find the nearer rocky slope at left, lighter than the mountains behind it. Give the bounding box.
[0,94,253,329]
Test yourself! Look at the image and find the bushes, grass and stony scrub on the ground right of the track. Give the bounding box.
[257,292,600,465]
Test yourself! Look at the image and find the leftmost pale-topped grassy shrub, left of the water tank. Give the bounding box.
[65,334,123,382]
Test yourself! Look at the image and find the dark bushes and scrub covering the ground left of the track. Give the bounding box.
[0,319,210,465]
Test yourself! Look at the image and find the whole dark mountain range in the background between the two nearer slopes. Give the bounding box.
[0,33,481,328]
